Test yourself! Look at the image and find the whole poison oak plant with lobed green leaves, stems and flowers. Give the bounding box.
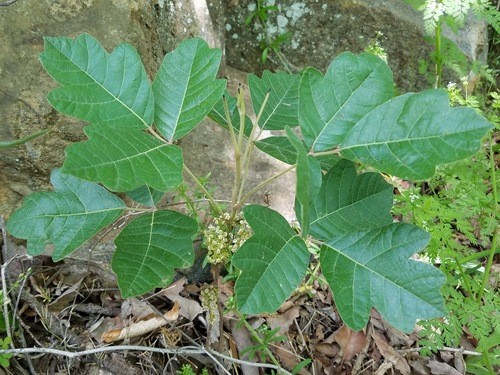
[8,35,491,331]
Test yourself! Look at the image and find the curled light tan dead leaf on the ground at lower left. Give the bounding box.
[101,302,179,343]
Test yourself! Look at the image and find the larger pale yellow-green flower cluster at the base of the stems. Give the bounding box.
[205,212,251,265]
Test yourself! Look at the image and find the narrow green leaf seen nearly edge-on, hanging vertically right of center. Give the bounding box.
[285,127,323,238]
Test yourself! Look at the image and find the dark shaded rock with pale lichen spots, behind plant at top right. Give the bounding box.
[223,0,487,91]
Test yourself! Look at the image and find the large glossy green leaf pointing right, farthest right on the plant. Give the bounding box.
[340,90,492,180]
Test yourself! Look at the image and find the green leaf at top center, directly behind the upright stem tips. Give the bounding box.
[248,70,300,130]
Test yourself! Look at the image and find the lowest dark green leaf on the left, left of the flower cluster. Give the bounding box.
[111,210,198,298]
